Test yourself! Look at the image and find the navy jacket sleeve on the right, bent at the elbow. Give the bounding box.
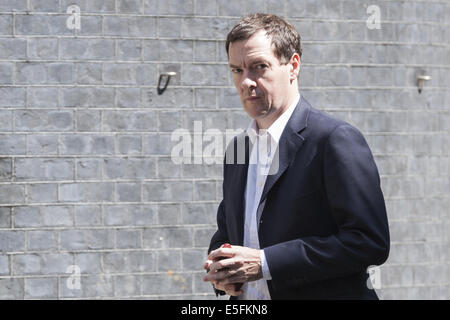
[264,124,389,290]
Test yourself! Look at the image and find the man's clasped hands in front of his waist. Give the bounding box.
[203,246,263,296]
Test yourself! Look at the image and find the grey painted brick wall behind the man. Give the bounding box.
[0,0,450,299]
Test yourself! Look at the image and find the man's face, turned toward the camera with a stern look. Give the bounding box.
[228,31,296,121]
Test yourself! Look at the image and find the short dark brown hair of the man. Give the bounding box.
[225,13,302,64]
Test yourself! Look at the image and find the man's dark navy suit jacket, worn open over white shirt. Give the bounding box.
[208,97,390,299]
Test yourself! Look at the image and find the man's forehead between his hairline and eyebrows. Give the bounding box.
[228,30,276,63]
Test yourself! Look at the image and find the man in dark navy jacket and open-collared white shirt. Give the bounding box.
[203,14,389,299]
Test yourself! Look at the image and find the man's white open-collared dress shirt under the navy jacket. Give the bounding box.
[238,96,300,300]
